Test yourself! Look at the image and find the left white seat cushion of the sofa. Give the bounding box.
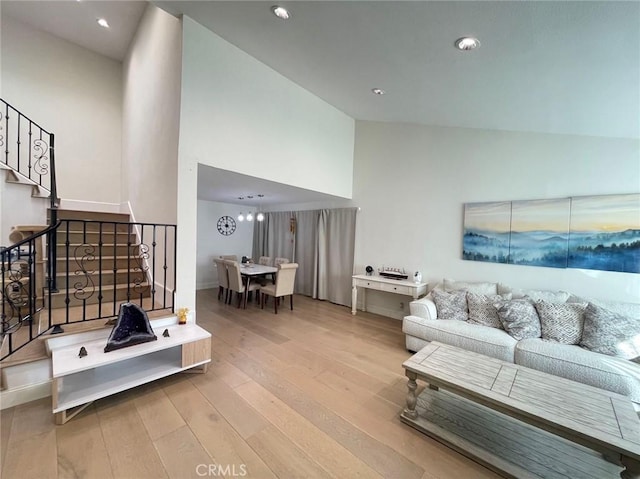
[402,316,517,363]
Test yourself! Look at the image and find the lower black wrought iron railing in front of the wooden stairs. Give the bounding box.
[0,219,177,360]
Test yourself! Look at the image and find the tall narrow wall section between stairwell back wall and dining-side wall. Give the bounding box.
[121,4,182,223]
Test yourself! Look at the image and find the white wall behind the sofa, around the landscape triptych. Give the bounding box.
[353,121,640,316]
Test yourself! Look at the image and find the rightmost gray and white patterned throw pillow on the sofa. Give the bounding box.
[580,303,640,360]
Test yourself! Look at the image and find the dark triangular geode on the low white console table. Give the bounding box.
[104,303,158,353]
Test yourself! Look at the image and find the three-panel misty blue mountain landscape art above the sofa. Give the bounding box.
[462,194,640,273]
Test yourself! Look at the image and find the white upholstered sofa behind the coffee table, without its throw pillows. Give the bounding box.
[402,281,640,404]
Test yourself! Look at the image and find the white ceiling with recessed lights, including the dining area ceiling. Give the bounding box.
[1,0,640,207]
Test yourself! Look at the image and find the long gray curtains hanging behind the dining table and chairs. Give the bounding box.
[253,208,357,306]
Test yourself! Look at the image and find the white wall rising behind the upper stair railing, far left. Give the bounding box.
[0,15,122,203]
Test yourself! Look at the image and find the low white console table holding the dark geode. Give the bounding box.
[51,322,211,424]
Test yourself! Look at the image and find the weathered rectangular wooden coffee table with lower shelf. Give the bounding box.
[400,342,640,479]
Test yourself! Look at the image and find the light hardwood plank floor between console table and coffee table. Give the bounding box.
[0,290,498,479]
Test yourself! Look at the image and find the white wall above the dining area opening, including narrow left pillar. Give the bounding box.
[178,17,354,309]
